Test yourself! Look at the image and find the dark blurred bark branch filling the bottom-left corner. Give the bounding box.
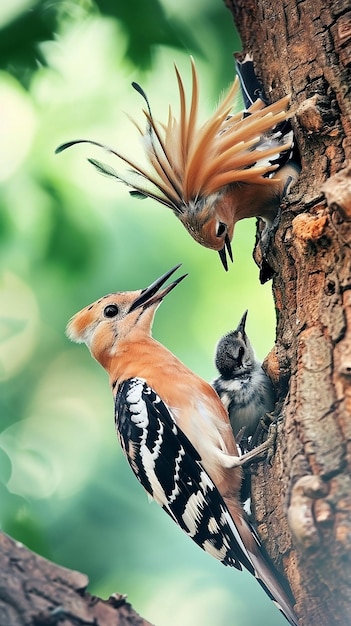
[0,533,151,626]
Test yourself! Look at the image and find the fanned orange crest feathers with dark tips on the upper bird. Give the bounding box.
[56,60,291,213]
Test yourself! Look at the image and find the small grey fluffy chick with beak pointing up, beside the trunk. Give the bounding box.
[212,311,275,449]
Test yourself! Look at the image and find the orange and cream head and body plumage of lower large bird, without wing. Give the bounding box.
[67,270,241,502]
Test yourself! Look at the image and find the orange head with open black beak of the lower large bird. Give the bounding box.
[66,265,187,367]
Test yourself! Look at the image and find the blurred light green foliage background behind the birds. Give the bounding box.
[0,0,283,626]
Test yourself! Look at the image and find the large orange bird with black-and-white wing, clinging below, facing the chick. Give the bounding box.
[67,265,298,626]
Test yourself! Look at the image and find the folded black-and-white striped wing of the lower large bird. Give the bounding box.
[115,378,254,574]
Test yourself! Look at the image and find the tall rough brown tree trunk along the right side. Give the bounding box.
[225,0,351,626]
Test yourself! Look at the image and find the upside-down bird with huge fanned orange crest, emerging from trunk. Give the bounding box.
[56,59,299,270]
